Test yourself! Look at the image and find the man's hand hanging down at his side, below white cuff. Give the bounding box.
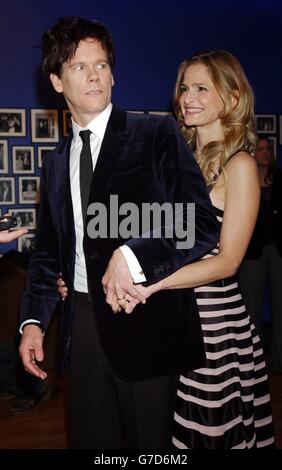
[19,325,47,380]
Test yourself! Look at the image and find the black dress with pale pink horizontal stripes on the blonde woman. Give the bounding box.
[173,208,274,449]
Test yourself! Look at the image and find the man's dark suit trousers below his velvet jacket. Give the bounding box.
[71,292,178,449]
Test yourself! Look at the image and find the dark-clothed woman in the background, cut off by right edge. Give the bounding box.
[240,134,282,373]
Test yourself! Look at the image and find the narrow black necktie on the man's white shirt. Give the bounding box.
[79,130,93,228]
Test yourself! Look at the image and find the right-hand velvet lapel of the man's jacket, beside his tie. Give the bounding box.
[89,107,129,203]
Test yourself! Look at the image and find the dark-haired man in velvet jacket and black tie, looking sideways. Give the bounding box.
[20,17,217,449]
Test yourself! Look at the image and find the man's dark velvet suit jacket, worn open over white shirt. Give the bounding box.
[21,107,218,381]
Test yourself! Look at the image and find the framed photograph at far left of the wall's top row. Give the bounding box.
[0,108,26,137]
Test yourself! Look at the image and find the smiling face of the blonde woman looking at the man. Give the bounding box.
[179,64,224,132]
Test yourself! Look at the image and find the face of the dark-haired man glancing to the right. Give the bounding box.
[50,38,114,127]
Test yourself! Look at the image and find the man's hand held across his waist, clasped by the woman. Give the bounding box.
[102,249,146,313]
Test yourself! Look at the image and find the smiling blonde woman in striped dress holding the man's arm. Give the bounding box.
[120,51,274,449]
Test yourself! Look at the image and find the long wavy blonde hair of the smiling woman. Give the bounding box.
[174,50,257,185]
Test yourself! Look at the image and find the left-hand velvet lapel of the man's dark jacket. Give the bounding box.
[54,132,74,245]
